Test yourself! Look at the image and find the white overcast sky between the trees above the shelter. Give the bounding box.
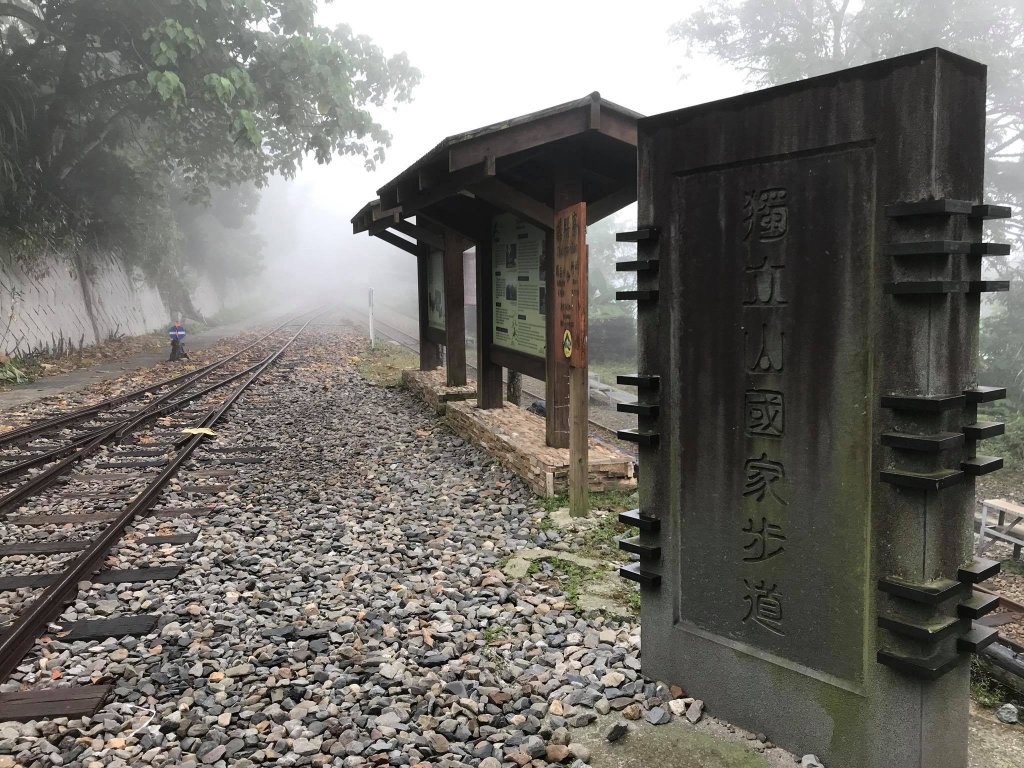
[260,0,746,303]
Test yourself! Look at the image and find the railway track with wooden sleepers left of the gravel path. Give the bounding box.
[0,313,314,721]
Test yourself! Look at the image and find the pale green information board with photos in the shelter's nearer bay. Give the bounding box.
[492,214,548,357]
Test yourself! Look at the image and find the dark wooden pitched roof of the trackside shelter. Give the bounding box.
[352,92,642,242]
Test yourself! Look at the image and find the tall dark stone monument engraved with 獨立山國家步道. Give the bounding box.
[621,49,1009,768]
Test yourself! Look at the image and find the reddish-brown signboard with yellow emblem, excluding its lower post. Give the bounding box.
[555,203,587,368]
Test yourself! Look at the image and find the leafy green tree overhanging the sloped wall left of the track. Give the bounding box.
[0,0,419,256]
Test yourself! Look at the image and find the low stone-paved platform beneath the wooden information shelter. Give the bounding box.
[445,400,637,496]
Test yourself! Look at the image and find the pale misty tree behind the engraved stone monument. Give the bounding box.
[669,0,1024,400]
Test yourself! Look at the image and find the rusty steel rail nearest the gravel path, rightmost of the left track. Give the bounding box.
[0,323,309,681]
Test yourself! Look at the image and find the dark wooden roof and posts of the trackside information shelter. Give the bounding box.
[352,92,641,447]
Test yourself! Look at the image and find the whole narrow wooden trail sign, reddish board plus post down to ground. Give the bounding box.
[554,203,590,517]
